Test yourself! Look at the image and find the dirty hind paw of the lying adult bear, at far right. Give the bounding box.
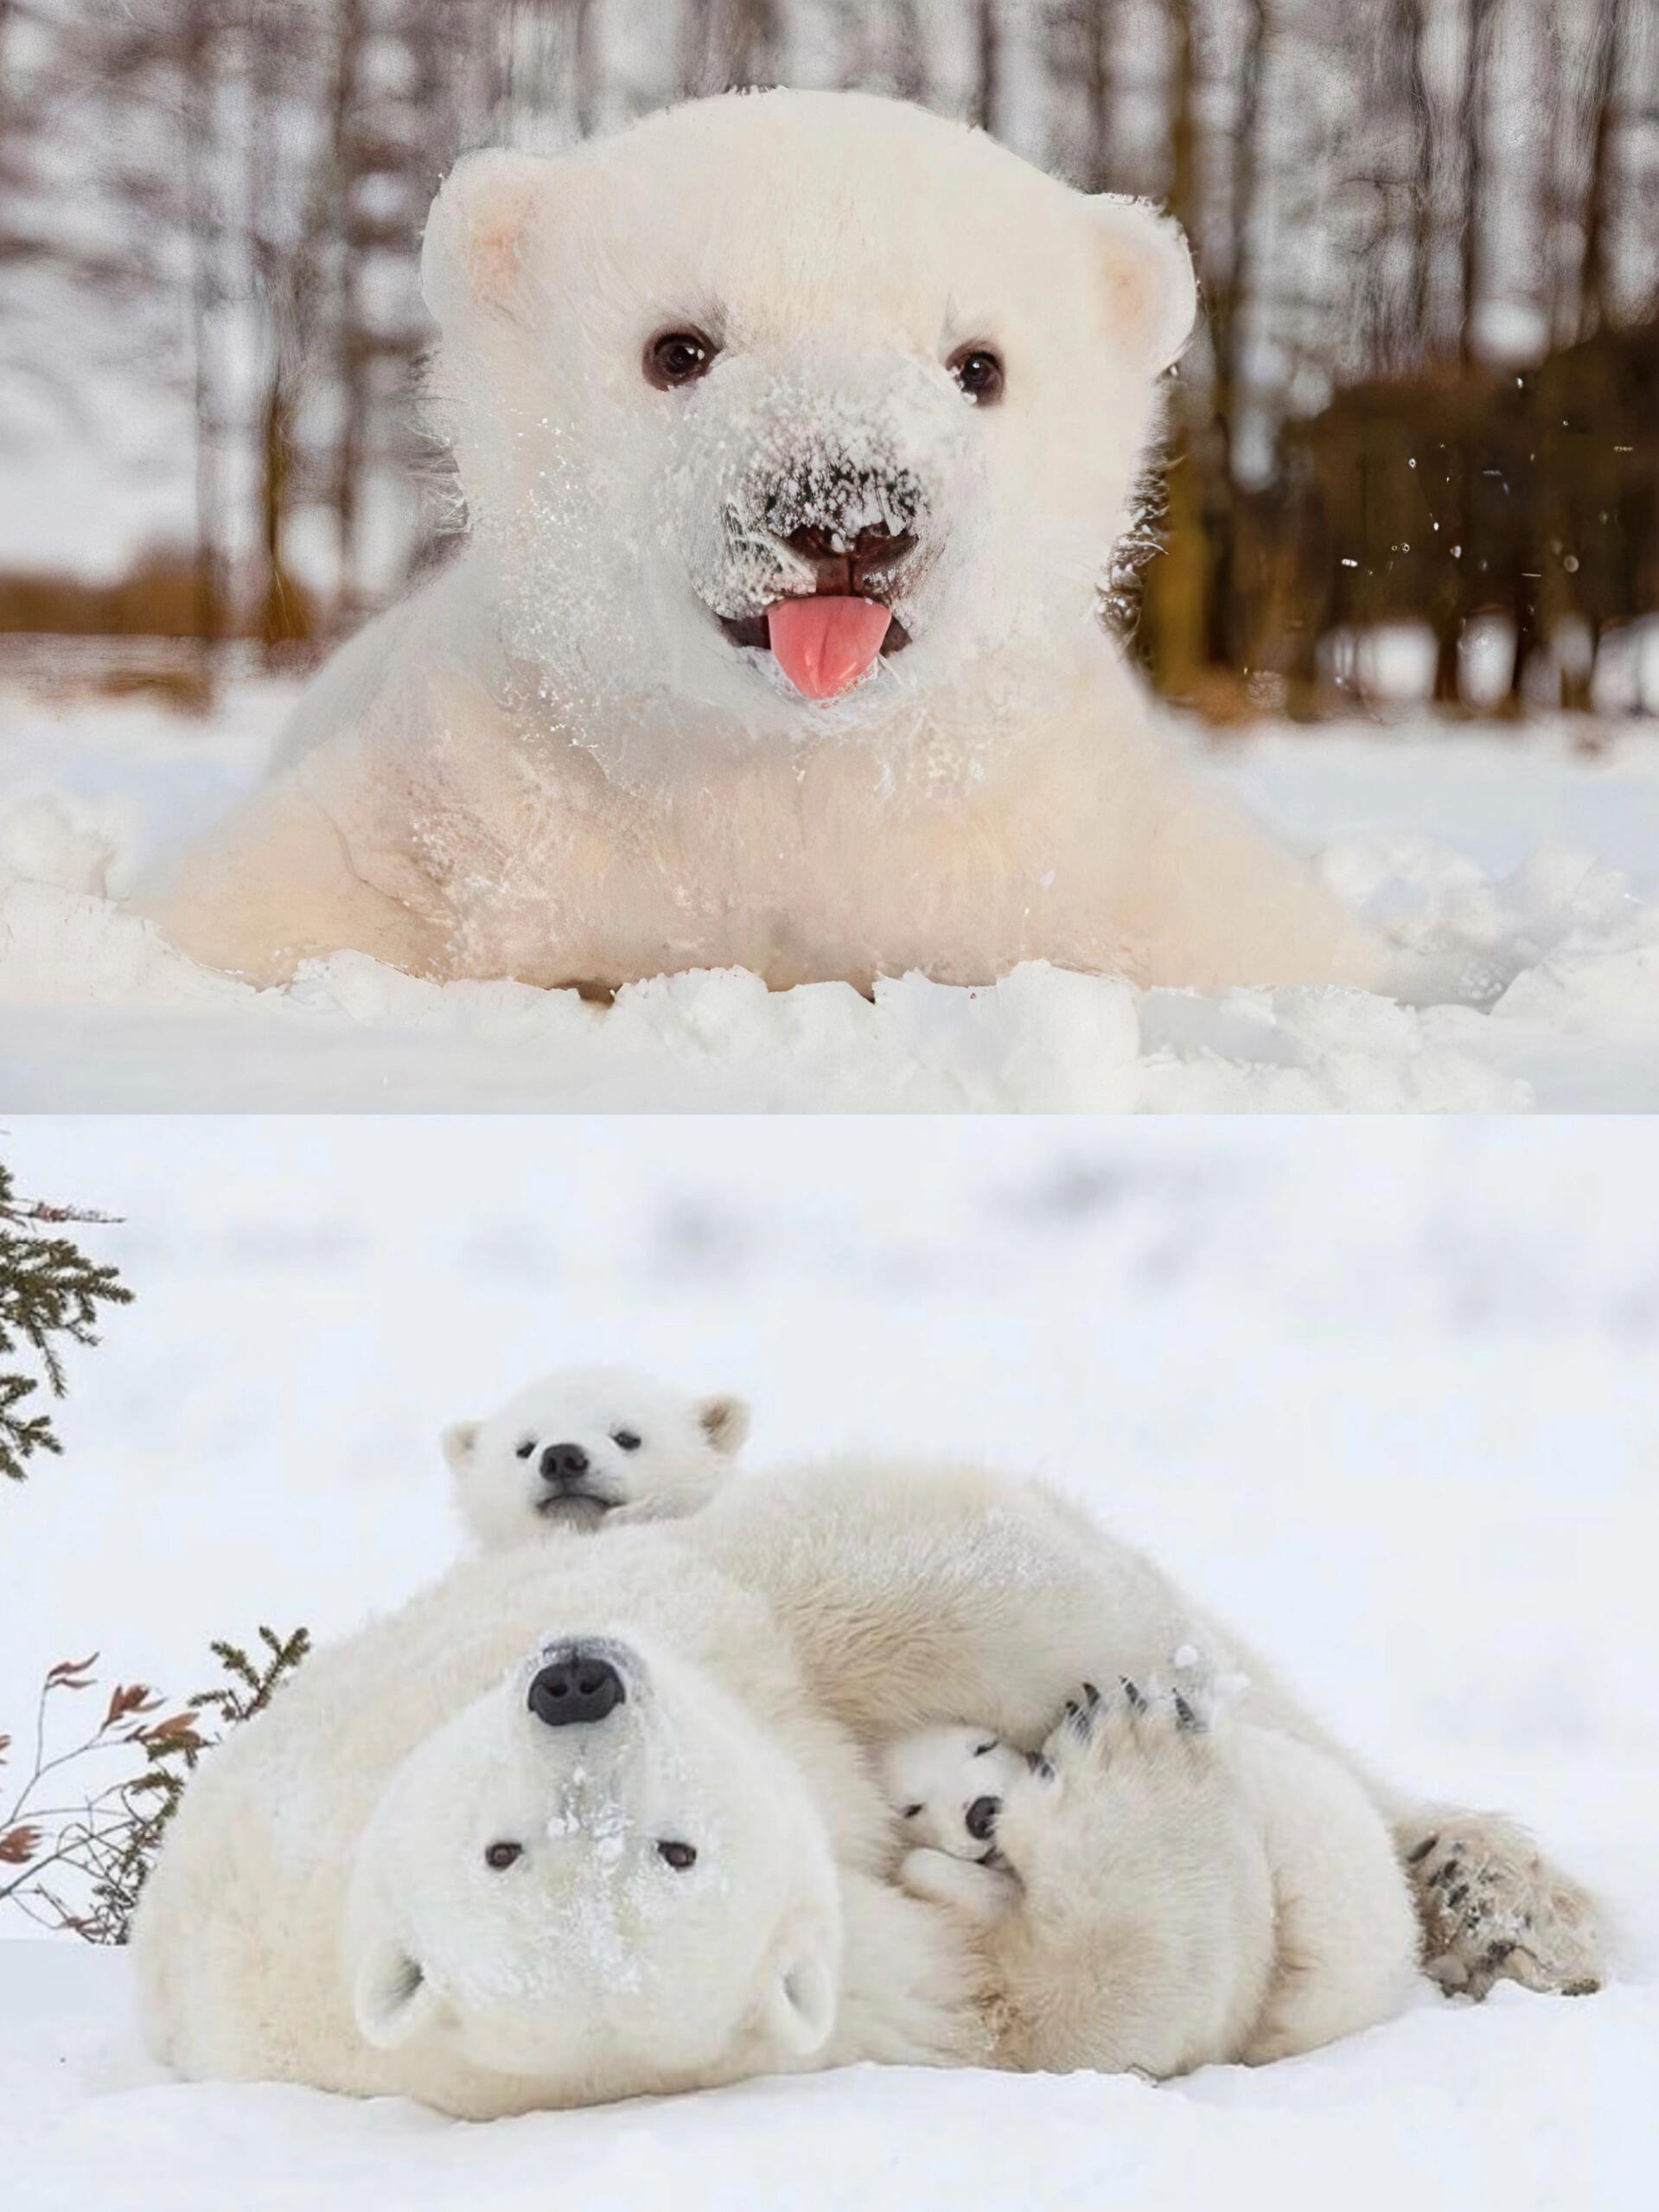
[1398,1812,1604,1998]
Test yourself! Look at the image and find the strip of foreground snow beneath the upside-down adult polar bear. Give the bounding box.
[0,1942,1659,2212]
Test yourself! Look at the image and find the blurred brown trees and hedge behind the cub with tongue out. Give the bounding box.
[0,0,1659,719]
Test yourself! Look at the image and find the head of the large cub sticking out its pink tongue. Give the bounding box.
[423,91,1195,770]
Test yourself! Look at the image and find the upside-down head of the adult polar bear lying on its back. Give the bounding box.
[345,1633,840,2110]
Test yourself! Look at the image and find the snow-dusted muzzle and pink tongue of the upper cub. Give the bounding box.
[668,356,971,699]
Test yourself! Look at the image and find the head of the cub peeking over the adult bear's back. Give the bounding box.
[443,1367,750,1544]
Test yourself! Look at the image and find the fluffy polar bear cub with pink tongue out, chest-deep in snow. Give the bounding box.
[135,91,1381,988]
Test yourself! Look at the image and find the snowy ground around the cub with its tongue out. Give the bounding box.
[0,683,1659,1113]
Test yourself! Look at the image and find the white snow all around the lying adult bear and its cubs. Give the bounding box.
[0,1119,1659,2212]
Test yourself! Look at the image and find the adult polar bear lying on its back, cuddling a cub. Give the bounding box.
[135,1467,1595,2117]
